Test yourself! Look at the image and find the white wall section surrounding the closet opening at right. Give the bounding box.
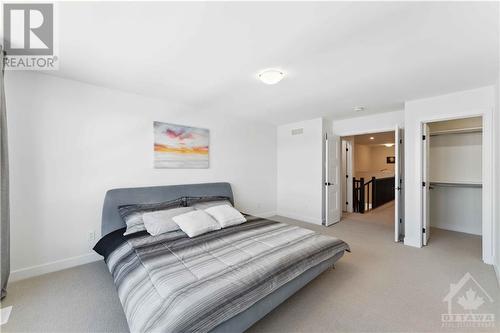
[404,86,494,263]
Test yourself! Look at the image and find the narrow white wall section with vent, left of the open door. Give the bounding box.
[277,118,324,224]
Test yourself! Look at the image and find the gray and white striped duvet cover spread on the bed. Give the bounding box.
[106,217,349,332]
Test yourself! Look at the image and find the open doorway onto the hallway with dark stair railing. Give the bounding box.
[341,128,403,241]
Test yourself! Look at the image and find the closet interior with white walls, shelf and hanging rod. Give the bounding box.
[422,117,483,256]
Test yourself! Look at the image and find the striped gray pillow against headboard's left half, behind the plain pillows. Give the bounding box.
[118,198,184,236]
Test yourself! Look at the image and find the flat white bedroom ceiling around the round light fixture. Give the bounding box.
[41,2,499,124]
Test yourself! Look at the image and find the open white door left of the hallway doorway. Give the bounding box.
[325,135,342,225]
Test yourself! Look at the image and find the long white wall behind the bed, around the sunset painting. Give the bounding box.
[6,72,278,279]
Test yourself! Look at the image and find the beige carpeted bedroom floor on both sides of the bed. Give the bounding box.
[1,208,500,333]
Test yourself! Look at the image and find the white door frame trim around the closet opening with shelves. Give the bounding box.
[417,113,495,265]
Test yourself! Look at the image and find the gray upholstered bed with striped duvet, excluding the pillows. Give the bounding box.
[95,183,349,333]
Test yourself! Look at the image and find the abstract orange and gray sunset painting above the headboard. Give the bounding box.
[154,121,210,169]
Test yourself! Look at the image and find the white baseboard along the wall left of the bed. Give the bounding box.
[9,253,102,282]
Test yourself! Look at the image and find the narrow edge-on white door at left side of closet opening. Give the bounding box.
[422,124,431,245]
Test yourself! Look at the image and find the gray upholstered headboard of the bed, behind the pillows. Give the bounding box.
[101,183,234,237]
